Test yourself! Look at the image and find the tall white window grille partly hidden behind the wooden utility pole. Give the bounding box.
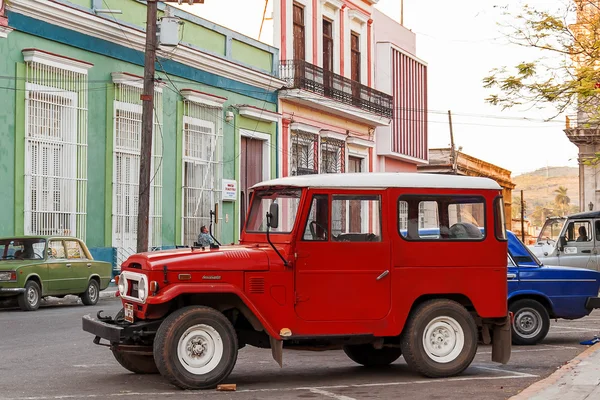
[112,83,163,265]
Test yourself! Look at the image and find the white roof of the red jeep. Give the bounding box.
[251,172,502,190]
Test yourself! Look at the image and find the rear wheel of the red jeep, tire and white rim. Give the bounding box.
[401,299,477,378]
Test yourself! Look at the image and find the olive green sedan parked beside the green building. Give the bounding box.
[0,236,112,311]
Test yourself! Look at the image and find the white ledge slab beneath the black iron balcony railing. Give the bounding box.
[279,89,392,126]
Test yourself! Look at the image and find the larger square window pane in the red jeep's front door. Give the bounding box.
[331,195,381,242]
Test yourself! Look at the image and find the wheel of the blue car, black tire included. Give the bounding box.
[509,299,550,346]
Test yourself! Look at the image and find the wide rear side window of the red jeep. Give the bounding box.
[398,195,486,241]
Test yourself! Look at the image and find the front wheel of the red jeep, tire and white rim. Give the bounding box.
[154,306,238,389]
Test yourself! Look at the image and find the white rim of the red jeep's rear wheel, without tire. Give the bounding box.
[423,316,465,364]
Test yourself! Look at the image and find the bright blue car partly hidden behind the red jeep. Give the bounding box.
[507,231,600,345]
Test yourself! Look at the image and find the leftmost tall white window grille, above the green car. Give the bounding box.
[24,61,88,240]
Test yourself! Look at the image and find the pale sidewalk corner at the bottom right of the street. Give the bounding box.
[509,343,600,400]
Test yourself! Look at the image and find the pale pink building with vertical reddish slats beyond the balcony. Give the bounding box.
[372,9,428,172]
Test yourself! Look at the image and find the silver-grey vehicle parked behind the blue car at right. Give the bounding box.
[529,211,600,271]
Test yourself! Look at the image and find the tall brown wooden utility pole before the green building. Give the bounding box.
[137,0,158,253]
